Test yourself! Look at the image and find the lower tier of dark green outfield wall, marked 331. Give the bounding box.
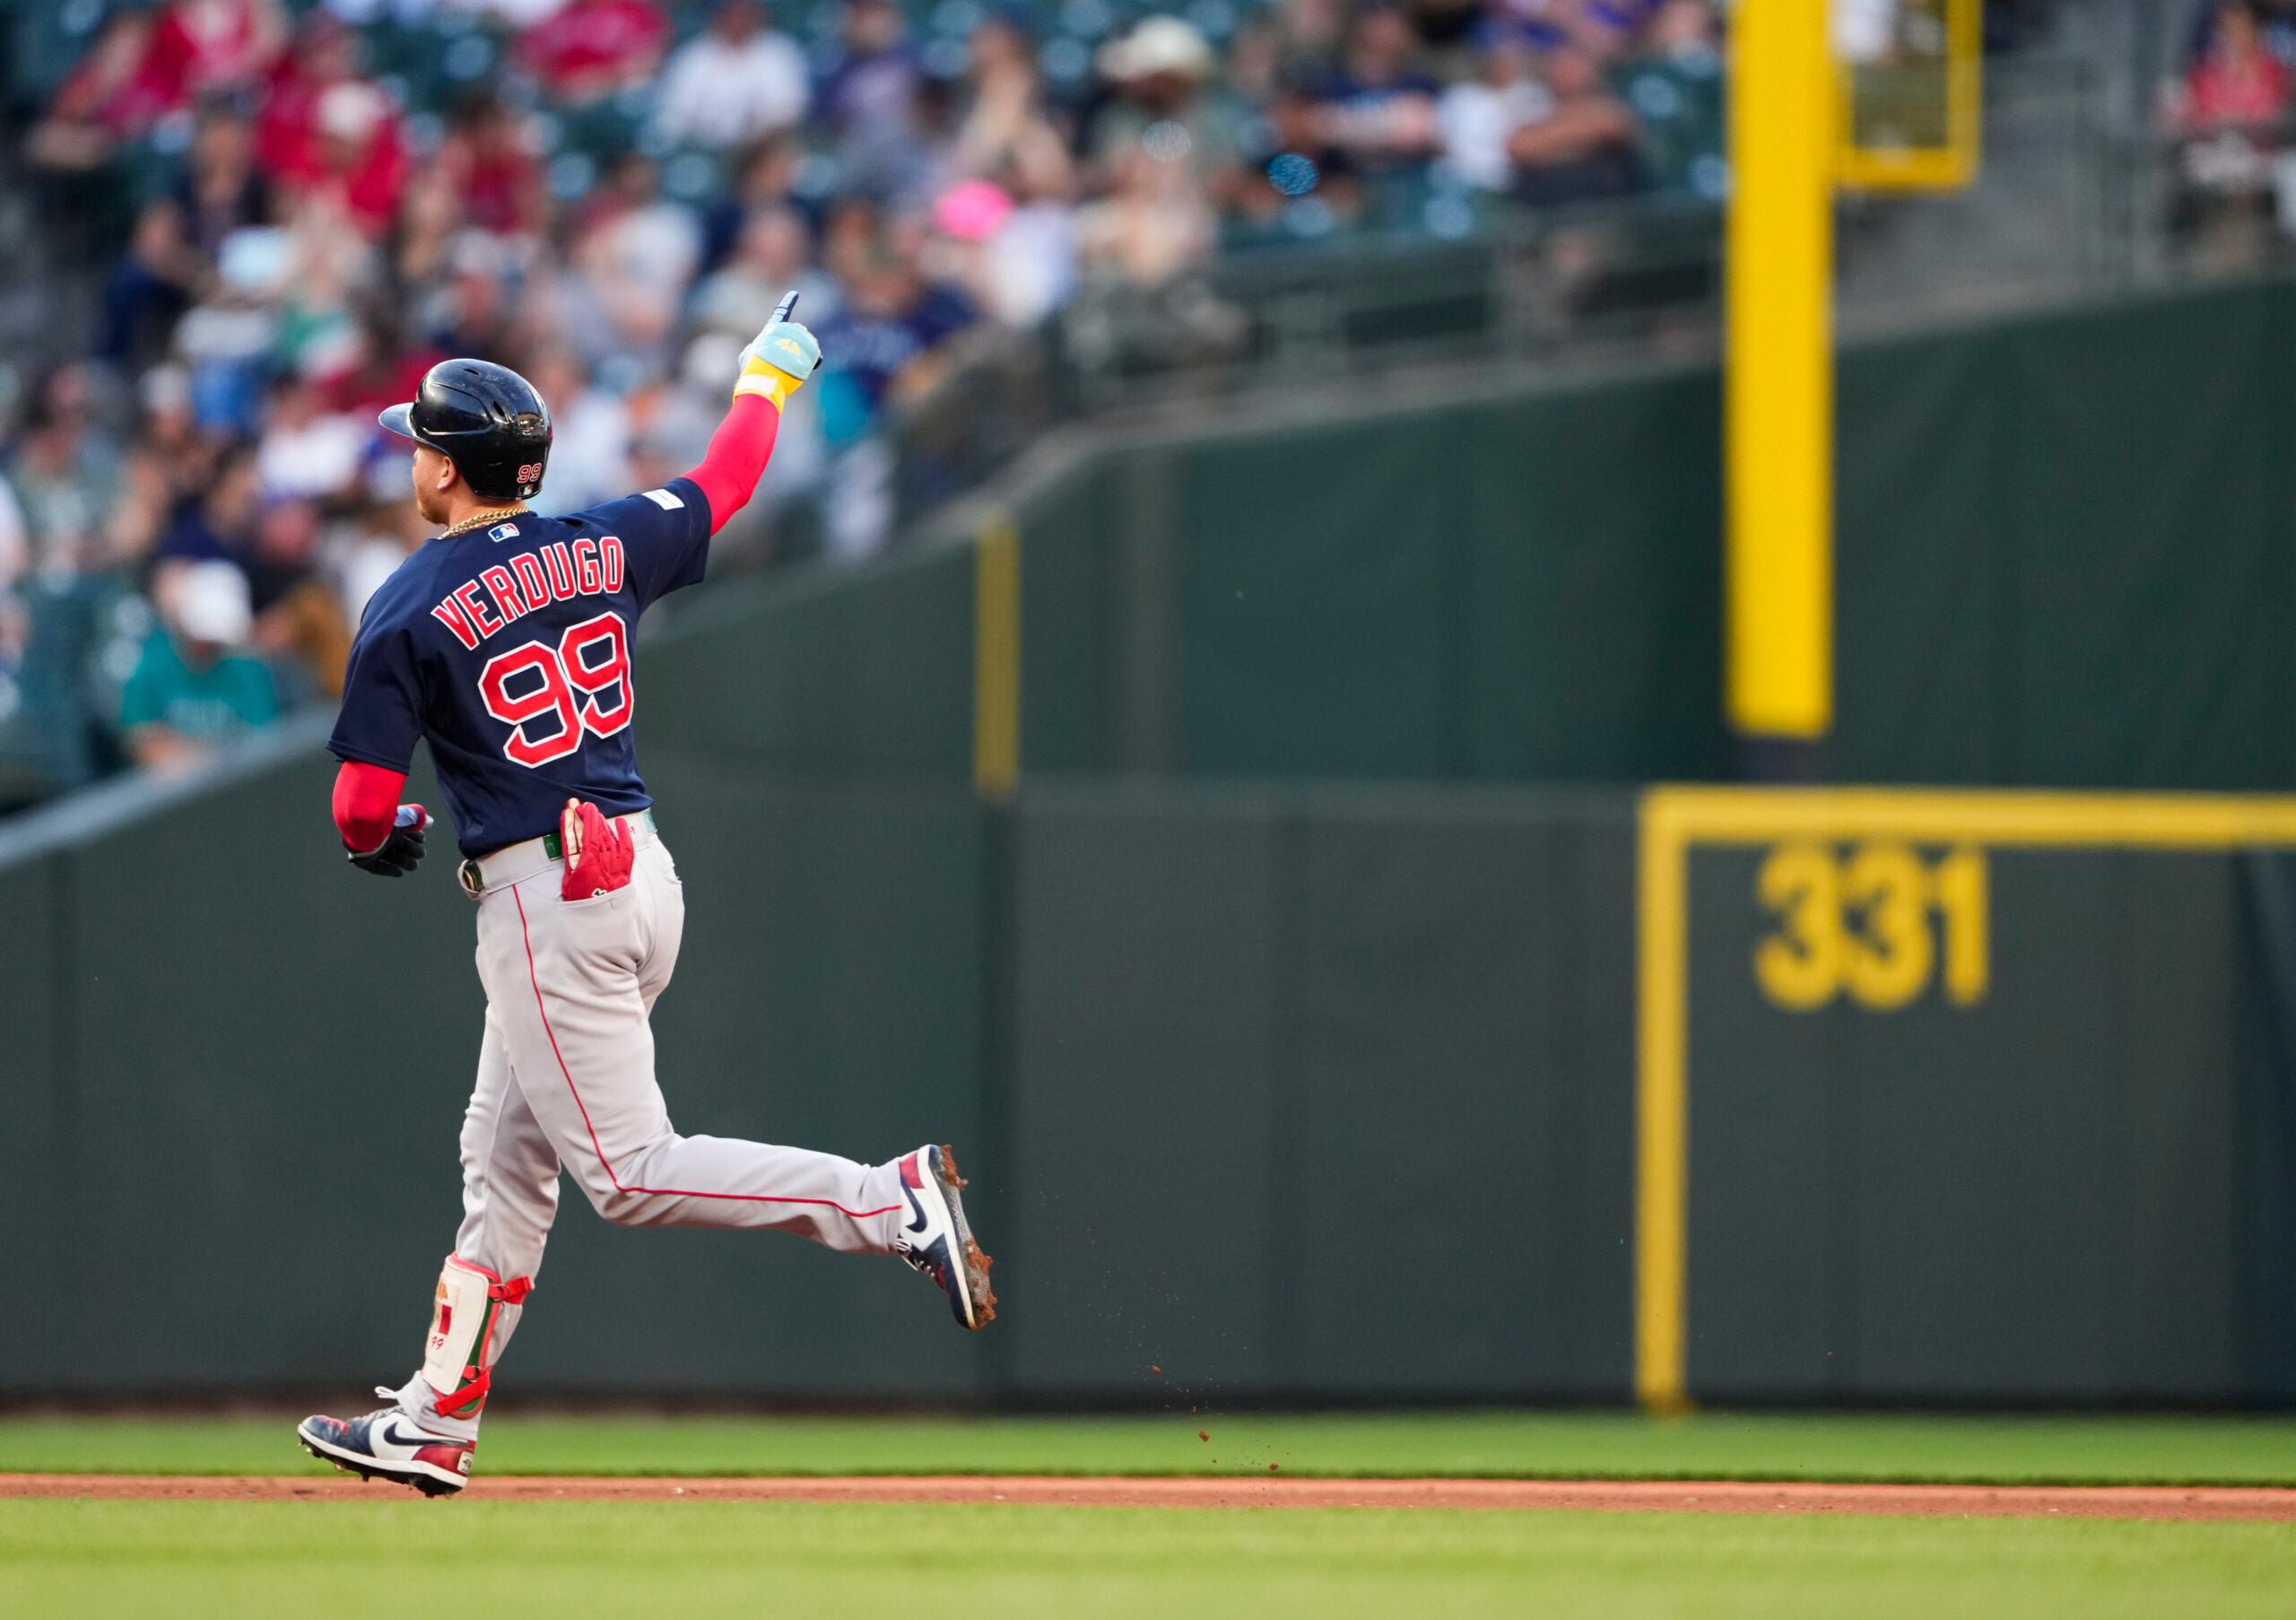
[0,749,2296,1404]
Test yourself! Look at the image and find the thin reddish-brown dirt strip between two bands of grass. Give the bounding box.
[0,1473,2296,1521]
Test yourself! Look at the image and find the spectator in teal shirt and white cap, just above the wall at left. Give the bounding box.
[119,561,278,770]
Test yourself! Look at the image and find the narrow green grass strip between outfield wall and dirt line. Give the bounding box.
[0,1411,2296,1488]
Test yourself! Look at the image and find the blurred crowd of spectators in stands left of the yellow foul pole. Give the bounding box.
[0,0,1719,806]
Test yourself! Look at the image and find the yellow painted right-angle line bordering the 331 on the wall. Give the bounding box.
[1635,786,2296,1411]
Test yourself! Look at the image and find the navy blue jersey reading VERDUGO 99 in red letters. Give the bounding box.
[328,478,709,855]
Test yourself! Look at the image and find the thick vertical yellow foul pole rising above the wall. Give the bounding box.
[1725,0,1834,740]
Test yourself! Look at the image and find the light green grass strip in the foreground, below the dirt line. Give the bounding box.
[0,1501,2296,1620]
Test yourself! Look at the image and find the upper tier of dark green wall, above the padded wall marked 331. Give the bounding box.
[649,281,2296,790]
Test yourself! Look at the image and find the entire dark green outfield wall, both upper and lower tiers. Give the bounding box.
[0,283,2296,1404]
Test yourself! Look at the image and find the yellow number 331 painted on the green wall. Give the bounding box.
[1754,841,1991,1014]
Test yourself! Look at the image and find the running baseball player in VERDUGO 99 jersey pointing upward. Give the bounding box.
[296,294,996,1496]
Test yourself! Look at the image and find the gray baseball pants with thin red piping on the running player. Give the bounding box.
[395,821,902,1439]
